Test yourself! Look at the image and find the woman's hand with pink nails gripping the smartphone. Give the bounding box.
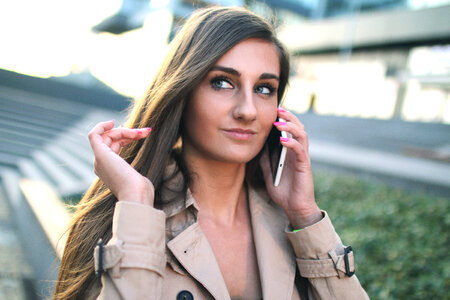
[260,108,322,229]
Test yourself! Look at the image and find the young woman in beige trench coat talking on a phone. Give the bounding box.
[54,8,368,299]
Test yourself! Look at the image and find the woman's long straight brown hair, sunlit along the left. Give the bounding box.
[53,7,289,299]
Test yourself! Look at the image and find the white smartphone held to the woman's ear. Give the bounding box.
[268,118,290,186]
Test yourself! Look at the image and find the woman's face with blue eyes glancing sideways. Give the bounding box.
[183,38,280,163]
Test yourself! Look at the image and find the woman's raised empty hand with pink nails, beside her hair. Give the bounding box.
[88,120,154,206]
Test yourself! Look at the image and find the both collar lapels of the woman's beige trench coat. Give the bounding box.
[163,183,296,299]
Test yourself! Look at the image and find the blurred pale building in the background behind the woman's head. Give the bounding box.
[93,0,450,123]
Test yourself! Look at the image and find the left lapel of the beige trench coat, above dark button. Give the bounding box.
[167,222,230,299]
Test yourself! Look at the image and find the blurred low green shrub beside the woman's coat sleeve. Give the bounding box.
[314,170,450,299]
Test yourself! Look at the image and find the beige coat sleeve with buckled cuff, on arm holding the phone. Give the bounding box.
[287,212,369,300]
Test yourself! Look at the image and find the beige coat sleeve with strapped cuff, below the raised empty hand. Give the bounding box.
[94,201,166,300]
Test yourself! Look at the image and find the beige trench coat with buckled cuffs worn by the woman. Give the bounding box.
[89,175,368,300]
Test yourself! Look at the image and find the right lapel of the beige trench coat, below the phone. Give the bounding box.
[249,188,296,299]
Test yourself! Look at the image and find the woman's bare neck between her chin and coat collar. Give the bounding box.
[185,152,247,226]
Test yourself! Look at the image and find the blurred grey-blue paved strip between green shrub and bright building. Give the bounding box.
[298,113,450,195]
